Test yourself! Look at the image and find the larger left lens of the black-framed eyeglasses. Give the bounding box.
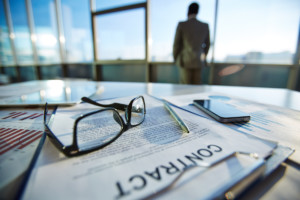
[76,110,123,151]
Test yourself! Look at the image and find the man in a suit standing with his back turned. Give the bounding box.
[173,3,210,84]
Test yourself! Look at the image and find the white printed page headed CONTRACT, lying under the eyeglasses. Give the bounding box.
[23,95,277,199]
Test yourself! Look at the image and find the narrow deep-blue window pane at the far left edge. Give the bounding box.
[0,1,15,65]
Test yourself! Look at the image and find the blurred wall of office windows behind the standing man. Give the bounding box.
[0,0,300,91]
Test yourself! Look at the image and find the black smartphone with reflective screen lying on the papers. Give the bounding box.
[194,99,250,123]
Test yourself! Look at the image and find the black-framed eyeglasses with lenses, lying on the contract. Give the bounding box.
[44,96,146,157]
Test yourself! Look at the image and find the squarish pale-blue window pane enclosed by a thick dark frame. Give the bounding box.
[96,8,145,60]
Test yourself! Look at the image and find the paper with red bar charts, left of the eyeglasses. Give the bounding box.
[0,109,44,199]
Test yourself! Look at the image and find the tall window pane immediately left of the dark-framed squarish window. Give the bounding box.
[61,0,93,62]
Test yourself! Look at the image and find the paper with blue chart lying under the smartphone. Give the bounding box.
[165,93,300,163]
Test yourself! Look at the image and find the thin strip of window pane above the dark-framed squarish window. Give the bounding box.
[96,0,146,11]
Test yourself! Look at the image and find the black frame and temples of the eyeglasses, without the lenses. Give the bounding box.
[44,96,146,157]
